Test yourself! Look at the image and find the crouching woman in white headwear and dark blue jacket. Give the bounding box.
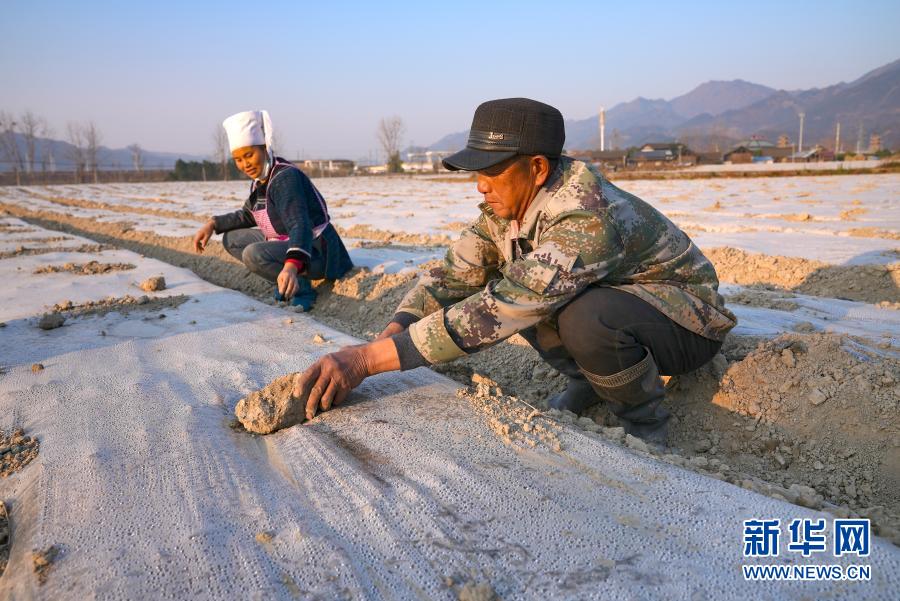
[194,111,353,311]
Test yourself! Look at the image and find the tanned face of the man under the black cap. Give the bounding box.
[477,156,543,219]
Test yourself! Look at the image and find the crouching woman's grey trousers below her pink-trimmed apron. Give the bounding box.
[222,228,325,282]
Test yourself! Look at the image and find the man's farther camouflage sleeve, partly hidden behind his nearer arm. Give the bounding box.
[395,215,500,319]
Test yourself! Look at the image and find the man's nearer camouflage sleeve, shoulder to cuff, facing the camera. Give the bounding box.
[409,211,625,363]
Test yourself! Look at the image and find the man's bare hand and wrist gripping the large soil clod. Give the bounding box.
[292,340,400,419]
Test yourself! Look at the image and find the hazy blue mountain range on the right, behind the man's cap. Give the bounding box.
[428,60,900,151]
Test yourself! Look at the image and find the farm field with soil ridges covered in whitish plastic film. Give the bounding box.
[0,174,900,598]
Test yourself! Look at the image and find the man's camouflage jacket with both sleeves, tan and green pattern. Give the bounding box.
[397,157,736,363]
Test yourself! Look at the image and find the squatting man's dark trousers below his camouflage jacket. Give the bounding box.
[521,287,722,376]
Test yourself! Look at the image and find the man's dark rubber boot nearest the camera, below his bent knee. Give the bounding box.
[581,347,670,447]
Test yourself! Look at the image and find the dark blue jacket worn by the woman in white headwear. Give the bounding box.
[213,157,353,280]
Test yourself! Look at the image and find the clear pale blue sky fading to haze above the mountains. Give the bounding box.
[0,0,900,159]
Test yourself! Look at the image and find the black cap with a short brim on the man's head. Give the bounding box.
[442,98,566,171]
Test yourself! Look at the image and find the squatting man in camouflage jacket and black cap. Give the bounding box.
[295,99,735,443]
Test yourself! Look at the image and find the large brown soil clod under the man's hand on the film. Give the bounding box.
[234,374,306,434]
